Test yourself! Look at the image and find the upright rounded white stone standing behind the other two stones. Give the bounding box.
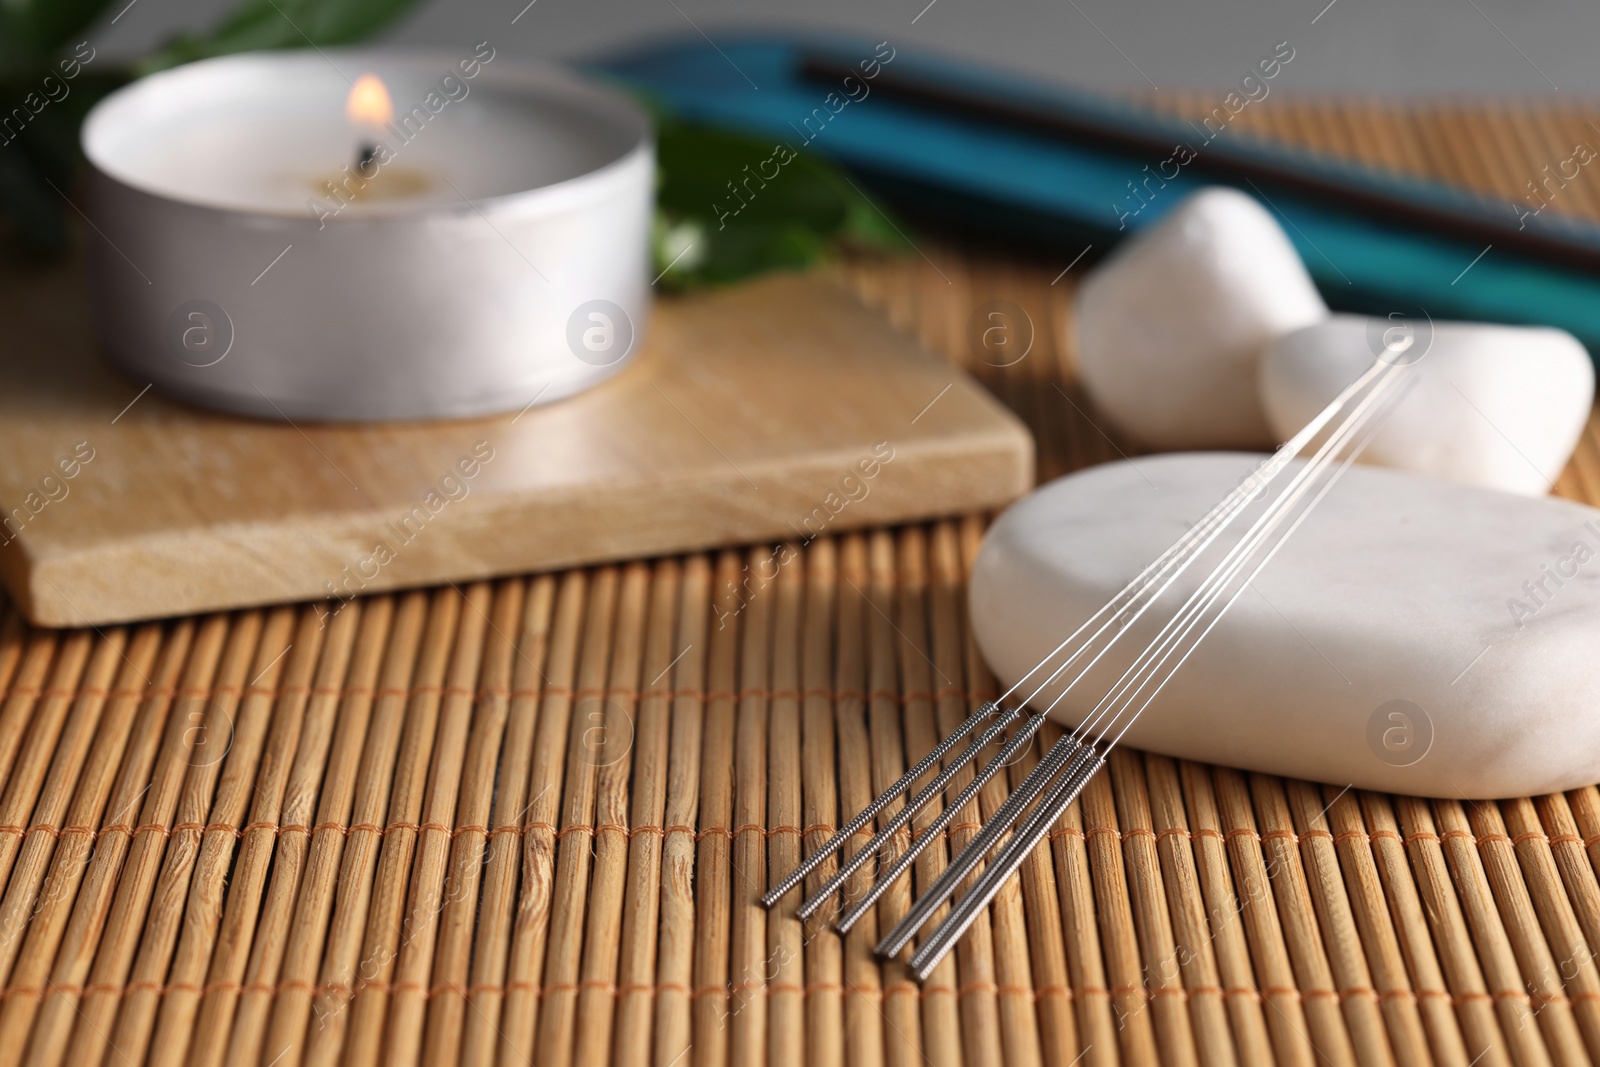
[1077,187,1328,450]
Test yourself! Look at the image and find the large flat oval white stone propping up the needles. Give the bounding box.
[970,453,1600,798]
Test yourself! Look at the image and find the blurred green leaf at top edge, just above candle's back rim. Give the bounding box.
[140,0,416,72]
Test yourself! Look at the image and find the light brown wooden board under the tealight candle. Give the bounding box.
[0,266,1034,625]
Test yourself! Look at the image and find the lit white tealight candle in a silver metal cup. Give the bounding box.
[83,45,654,419]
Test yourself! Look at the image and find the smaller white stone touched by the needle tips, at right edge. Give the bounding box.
[1261,315,1595,496]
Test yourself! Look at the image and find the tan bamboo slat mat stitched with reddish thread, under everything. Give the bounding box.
[0,99,1600,1067]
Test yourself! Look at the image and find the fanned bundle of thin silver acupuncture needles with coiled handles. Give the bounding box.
[762,347,1411,981]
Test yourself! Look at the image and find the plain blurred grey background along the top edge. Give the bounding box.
[91,0,1600,96]
